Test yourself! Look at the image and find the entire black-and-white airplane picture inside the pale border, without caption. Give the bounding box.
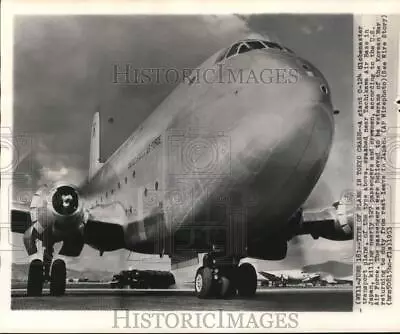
[9,14,355,314]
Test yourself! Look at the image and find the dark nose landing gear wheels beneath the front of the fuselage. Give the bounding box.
[195,253,257,298]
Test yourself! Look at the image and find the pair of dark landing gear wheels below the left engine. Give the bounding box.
[27,247,67,296]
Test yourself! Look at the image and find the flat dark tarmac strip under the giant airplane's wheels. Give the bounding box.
[11,288,353,312]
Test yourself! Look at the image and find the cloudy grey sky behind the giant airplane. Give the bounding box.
[14,15,353,270]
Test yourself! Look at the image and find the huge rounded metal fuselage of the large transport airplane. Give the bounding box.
[80,41,334,258]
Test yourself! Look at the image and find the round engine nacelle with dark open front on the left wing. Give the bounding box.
[30,184,84,239]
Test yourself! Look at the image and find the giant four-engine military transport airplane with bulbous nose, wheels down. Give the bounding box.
[11,39,353,298]
